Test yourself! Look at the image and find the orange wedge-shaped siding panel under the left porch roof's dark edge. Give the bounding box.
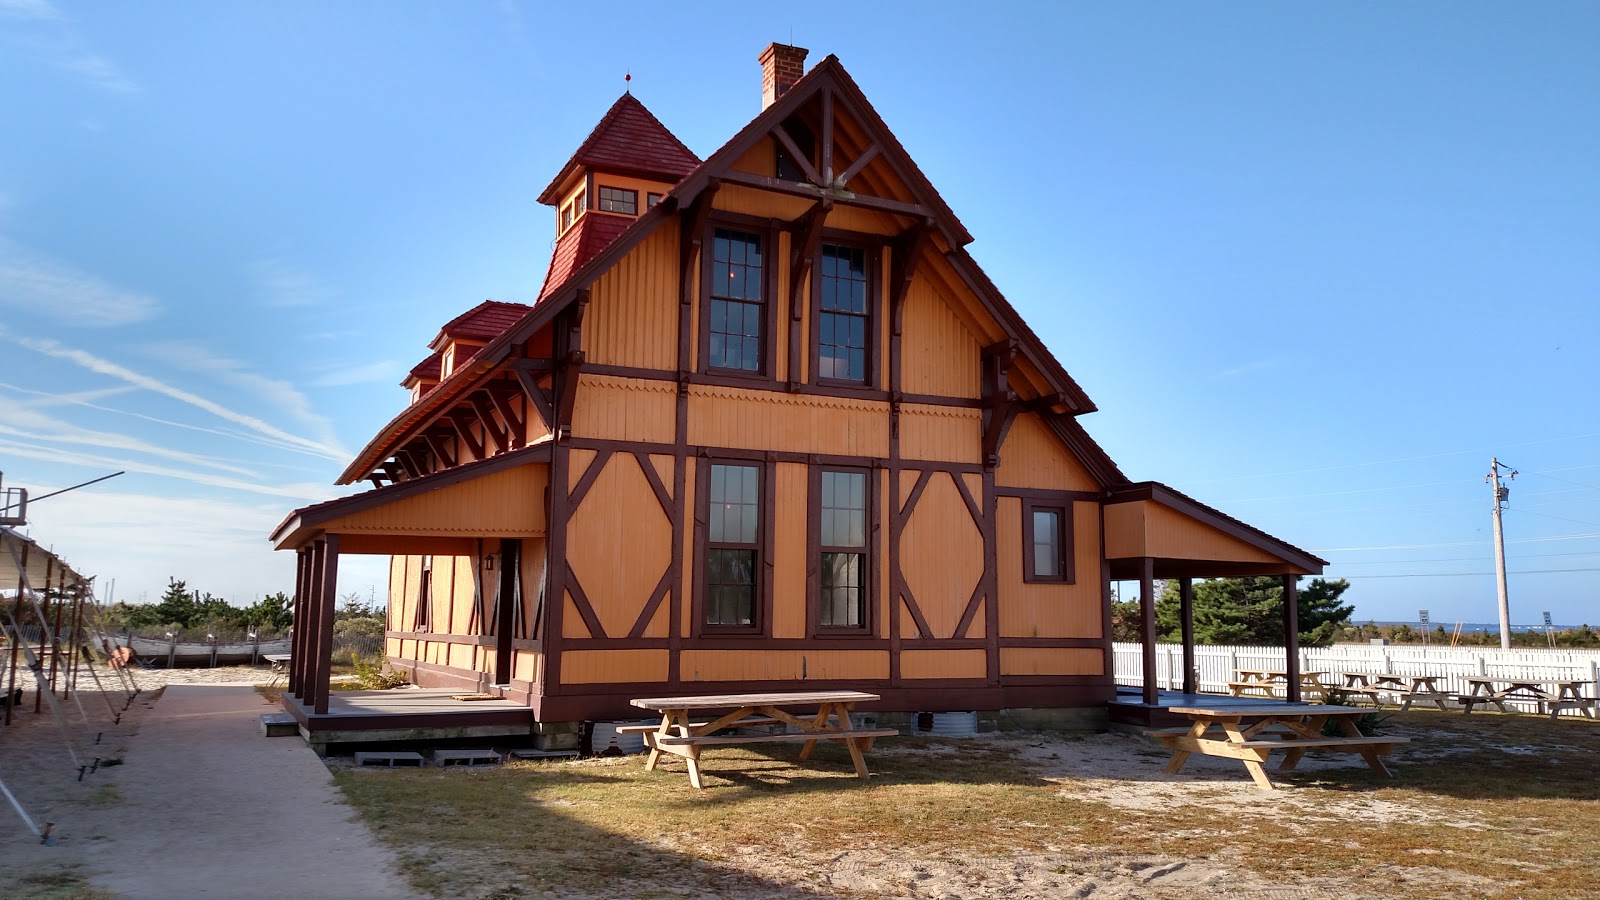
[323,463,550,536]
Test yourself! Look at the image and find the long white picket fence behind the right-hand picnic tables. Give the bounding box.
[1112,642,1600,709]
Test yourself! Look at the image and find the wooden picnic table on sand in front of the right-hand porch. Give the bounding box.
[1155,703,1408,791]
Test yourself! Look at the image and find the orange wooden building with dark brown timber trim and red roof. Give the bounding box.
[272,45,1322,739]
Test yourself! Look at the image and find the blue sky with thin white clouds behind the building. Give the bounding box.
[0,0,1600,623]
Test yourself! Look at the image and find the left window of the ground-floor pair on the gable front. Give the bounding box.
[701,463,762,628]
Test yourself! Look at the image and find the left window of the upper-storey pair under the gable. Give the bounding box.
[706,227,766,375]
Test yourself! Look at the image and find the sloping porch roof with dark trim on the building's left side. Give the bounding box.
[270,439,550,554]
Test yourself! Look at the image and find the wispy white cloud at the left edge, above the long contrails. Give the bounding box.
[0,237,162,327]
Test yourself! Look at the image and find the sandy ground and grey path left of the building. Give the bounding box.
[0,666,408,900]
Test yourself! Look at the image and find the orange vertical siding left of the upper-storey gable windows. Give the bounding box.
[592,225,678,369]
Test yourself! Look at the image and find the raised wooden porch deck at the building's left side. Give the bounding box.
[283,689,533,753]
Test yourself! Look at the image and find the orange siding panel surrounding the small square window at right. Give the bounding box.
[995,496,1104,637]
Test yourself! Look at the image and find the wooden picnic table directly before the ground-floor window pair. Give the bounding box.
[618,690,899,788]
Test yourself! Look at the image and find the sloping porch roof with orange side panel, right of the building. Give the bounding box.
[1106,482,1328,578]
